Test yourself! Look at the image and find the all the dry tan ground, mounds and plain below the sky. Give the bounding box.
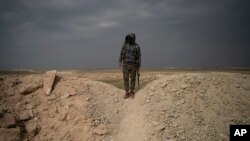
[0,70,250,141]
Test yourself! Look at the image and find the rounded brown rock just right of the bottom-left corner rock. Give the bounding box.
[26,121,41,139]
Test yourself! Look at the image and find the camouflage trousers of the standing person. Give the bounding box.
[122,64,137,92]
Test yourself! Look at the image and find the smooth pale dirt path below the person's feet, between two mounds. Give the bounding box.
[116,91,149,141]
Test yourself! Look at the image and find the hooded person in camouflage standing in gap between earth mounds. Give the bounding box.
[119,33,141,99]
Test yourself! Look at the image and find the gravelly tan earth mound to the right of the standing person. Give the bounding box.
[140,73,250,141]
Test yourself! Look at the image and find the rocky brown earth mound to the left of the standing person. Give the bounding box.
[0,75,121,141]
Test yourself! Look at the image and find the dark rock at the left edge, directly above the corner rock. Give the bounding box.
[0,113,16,128]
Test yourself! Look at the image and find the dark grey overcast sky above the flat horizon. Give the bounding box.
[0,0,250,69]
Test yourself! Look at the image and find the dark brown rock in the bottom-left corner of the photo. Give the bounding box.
[0,127,21,141]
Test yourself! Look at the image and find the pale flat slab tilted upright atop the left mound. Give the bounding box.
[43,70,57,95]
